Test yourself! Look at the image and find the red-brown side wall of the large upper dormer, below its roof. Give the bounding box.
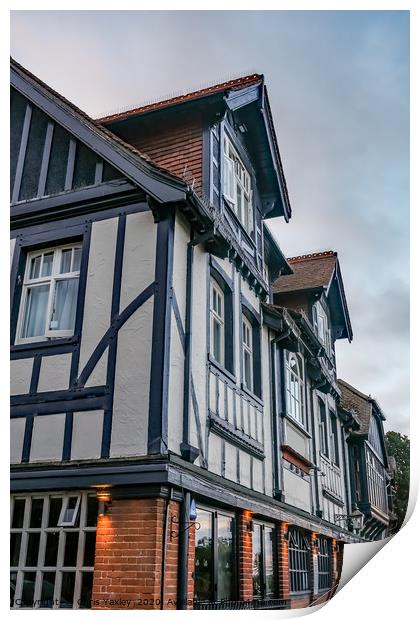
[124,116,203,194]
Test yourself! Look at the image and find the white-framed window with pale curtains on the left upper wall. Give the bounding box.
[16,243,82,343]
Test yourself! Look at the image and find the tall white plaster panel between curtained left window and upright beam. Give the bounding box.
[79,217,118,373]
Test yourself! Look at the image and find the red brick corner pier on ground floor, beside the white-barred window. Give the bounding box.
[92,498,179,609]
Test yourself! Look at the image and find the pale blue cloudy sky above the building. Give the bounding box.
[11,11,409,434]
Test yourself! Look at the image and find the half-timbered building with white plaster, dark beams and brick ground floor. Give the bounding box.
[10,61,394,609]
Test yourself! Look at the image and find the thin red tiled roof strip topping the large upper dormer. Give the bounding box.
[96,73,264,124]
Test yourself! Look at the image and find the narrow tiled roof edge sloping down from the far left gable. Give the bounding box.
[10,58,182,182]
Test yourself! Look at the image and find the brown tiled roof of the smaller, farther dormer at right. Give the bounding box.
[273,250,337,293]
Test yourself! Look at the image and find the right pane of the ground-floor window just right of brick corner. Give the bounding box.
[217,515,234,601]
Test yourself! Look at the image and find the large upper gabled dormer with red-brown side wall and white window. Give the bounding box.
[97,74,291,284]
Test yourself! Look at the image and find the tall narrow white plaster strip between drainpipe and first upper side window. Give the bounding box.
[190,246,208,456]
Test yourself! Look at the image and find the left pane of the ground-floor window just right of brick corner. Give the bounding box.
[194,509,212,601]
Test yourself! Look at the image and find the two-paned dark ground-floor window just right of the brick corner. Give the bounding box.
[194,508,237,601]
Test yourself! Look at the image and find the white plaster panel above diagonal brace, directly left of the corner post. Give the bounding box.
[120,211,157,311]
